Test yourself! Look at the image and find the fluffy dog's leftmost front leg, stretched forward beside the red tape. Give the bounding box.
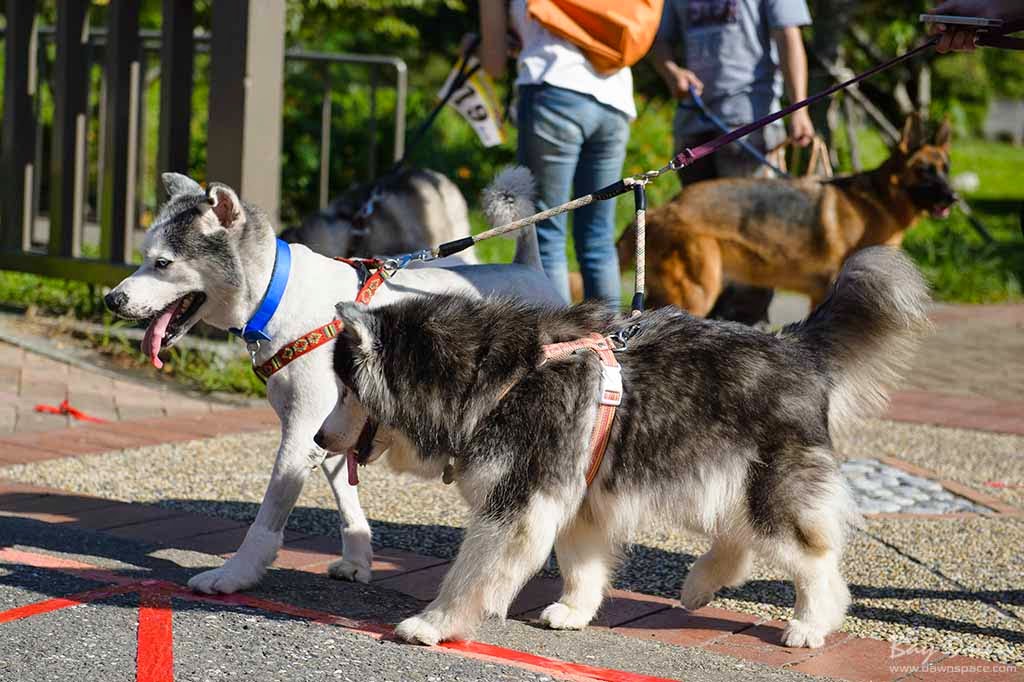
[394,494,566,645]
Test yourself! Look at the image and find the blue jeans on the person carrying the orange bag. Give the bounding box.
[517,85,630,308]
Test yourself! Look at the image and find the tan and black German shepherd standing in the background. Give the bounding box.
[618,116,956,316]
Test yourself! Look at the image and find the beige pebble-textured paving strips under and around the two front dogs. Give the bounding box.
[0,421,1024,664]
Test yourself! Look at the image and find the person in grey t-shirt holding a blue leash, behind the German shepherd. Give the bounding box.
[650,0,814,324]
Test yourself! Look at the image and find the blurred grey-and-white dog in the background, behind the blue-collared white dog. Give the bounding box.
[281,169,477,264]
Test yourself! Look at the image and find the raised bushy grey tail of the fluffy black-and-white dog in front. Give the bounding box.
[782,247,931,430]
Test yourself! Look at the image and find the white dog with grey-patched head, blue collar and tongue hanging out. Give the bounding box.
[105,168,560,593]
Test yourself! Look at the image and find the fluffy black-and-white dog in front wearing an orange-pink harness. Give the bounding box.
[318,248,929,647]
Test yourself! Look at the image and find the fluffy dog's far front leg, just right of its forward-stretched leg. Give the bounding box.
[541,512,615,630]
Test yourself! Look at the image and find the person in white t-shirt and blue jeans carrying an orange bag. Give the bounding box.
[480,0,636,307]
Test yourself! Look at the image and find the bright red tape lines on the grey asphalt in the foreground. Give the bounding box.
[0,548,673,682]
